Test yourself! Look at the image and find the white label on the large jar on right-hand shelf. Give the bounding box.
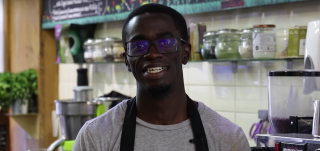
[252,33,276,52]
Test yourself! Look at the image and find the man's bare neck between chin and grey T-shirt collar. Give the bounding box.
[136,83,188,125]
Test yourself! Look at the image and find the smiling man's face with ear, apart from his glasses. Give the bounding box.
[126,13,190,94]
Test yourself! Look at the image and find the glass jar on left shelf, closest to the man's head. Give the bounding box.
[103,37,121,62]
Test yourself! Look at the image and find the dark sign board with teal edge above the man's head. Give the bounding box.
[42,0,311,29]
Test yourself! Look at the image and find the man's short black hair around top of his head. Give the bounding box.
[122,4,188,48]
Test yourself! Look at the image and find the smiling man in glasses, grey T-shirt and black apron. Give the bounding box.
[73,4,250,151]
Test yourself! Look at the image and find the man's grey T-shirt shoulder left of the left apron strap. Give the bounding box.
[73,100,127,151]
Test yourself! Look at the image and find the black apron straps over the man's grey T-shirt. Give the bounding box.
[120,95,209,151]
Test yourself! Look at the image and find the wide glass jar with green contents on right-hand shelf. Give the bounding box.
[215,29,241,59]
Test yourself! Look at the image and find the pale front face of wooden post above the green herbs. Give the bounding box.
[9,0,41,72]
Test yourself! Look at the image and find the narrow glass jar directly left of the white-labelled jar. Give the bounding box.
[239,28,253,59]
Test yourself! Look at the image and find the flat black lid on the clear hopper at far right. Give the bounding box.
[268,70,320,77]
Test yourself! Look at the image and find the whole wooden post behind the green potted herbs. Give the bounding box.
[4,0,59,151]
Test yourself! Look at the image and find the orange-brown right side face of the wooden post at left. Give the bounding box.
[38,29,59,148]
